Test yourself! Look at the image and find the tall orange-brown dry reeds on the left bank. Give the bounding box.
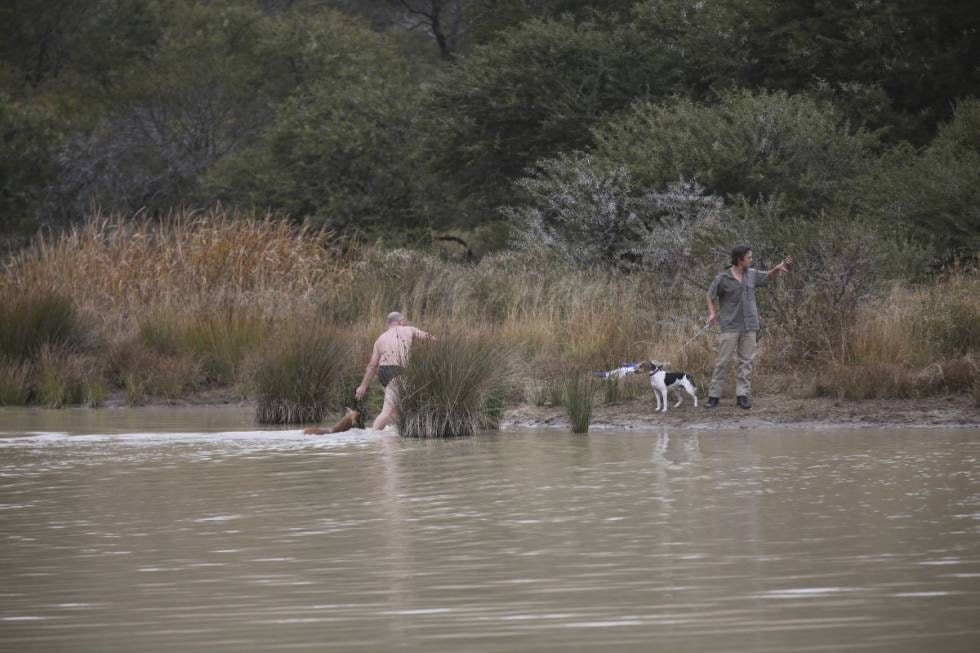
[2,209,342,316]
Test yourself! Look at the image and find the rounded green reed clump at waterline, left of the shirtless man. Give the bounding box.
[251,325,360,424]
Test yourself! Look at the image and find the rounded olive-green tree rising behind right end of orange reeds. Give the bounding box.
[205,13,415,232]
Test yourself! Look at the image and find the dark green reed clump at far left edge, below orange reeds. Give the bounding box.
[0,288,81,359]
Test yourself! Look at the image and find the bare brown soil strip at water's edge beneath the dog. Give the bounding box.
[504,395,980,429]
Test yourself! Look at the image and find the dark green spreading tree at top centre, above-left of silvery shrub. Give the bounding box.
[423,19,656,221]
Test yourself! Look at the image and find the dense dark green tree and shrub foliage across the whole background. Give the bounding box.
[0,0,980,262]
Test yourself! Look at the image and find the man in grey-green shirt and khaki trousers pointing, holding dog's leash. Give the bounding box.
[705,245,793,409]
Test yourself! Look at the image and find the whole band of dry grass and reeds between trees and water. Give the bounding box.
[0,210,980,430]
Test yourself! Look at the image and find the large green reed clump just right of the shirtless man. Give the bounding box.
[396,335,515,438]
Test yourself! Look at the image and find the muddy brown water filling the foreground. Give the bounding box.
[0,409,980,652]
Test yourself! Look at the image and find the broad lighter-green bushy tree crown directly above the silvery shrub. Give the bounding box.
[595,91,879,214]
